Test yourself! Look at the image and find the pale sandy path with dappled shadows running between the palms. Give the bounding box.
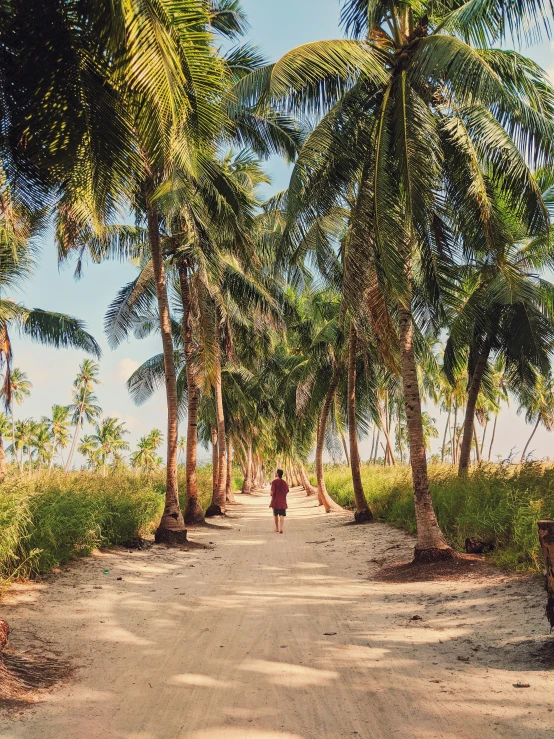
[0,492,554,739]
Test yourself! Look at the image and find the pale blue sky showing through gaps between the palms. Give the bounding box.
[9,0,554,468]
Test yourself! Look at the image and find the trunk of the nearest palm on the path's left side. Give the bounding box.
[145,194,187,543]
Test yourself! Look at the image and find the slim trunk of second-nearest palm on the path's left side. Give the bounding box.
[179,263,204,524]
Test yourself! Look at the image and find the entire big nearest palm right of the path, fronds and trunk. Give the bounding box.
[237,0,554,561]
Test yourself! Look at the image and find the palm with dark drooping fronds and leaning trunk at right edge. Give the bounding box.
[444,173,554,475]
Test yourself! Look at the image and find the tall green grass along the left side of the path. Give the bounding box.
[0,467,212,581]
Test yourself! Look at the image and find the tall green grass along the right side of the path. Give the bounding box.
[312,464,554,572]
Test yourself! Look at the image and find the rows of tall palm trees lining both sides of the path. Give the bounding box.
[0,0,554,561]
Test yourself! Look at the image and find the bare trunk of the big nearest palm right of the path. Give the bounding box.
[398,305,455,562]
